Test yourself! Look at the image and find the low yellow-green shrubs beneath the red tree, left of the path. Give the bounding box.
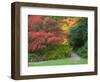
[28,45,72,62]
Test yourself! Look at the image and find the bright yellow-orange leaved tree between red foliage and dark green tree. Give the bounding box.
[60,17,80,44]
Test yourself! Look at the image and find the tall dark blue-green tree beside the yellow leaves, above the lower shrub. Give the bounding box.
[69,18,88,50]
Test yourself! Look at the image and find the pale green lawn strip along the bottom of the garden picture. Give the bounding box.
[28,58,88,66]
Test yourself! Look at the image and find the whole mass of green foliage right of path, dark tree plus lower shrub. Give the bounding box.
[69,18,88,58]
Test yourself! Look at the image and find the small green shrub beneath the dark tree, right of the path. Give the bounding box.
[77,42,88,58]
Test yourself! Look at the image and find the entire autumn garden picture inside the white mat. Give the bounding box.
[28,15,88,66]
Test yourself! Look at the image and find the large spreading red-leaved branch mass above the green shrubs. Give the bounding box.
[28,30,61,52]
